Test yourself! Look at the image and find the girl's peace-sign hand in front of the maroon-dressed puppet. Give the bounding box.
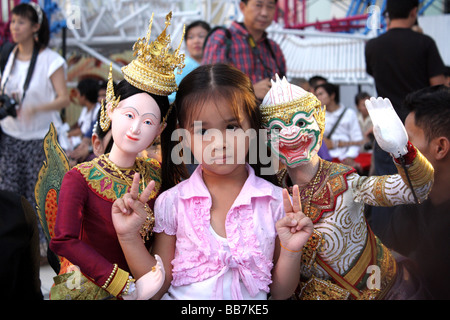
[111,173,155,240]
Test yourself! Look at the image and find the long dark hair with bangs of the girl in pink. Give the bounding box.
[161,64,275,191]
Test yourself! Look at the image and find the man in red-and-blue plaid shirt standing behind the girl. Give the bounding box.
[202,0,286,100]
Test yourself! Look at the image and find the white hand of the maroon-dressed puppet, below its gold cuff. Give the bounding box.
[123,254,166,300]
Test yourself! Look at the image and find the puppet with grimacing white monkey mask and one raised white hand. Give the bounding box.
[260,76,434,300]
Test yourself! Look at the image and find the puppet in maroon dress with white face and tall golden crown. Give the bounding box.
[50,12,184,300]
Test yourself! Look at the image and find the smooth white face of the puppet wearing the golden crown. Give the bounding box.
[108,93,161,155]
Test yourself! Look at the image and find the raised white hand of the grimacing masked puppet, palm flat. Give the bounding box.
[365,97,408,158]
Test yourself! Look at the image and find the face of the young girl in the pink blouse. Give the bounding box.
[185,99,251,175]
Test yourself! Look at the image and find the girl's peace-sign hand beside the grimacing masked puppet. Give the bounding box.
[276,185,314,252]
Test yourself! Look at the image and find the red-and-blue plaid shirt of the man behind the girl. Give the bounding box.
[202,22,286,83]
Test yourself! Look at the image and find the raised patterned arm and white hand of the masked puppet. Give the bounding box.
[353,98,434,206]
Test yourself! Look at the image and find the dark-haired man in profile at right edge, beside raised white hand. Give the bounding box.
[380,85,450,299]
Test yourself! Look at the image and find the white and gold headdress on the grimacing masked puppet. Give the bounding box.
[260,74,325,134]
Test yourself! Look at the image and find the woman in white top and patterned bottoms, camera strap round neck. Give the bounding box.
[0,2,69,258]
